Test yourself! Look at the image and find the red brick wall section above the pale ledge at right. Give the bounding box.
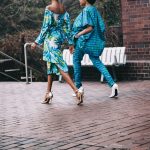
[121,0,150,60]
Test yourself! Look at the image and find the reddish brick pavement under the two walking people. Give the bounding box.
[0,81,150,150]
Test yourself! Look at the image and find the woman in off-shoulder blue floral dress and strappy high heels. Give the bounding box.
[31,0,83,105]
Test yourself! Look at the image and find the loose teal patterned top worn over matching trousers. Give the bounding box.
[72,6,105,56]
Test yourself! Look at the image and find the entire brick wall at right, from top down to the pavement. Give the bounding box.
[121,0,150,79]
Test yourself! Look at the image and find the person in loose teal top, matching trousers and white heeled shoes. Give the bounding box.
[71,0,118,98]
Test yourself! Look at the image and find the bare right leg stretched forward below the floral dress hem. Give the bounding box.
[59,69,78,92]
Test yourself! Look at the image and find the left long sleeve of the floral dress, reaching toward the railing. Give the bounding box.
[35,8,52,45]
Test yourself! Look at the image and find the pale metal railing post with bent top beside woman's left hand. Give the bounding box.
[24,43,32,84]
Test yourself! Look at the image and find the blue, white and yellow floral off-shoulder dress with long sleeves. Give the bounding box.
[35,8,73,75]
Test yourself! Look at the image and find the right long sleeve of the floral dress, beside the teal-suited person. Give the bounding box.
[63,13,74,45]
